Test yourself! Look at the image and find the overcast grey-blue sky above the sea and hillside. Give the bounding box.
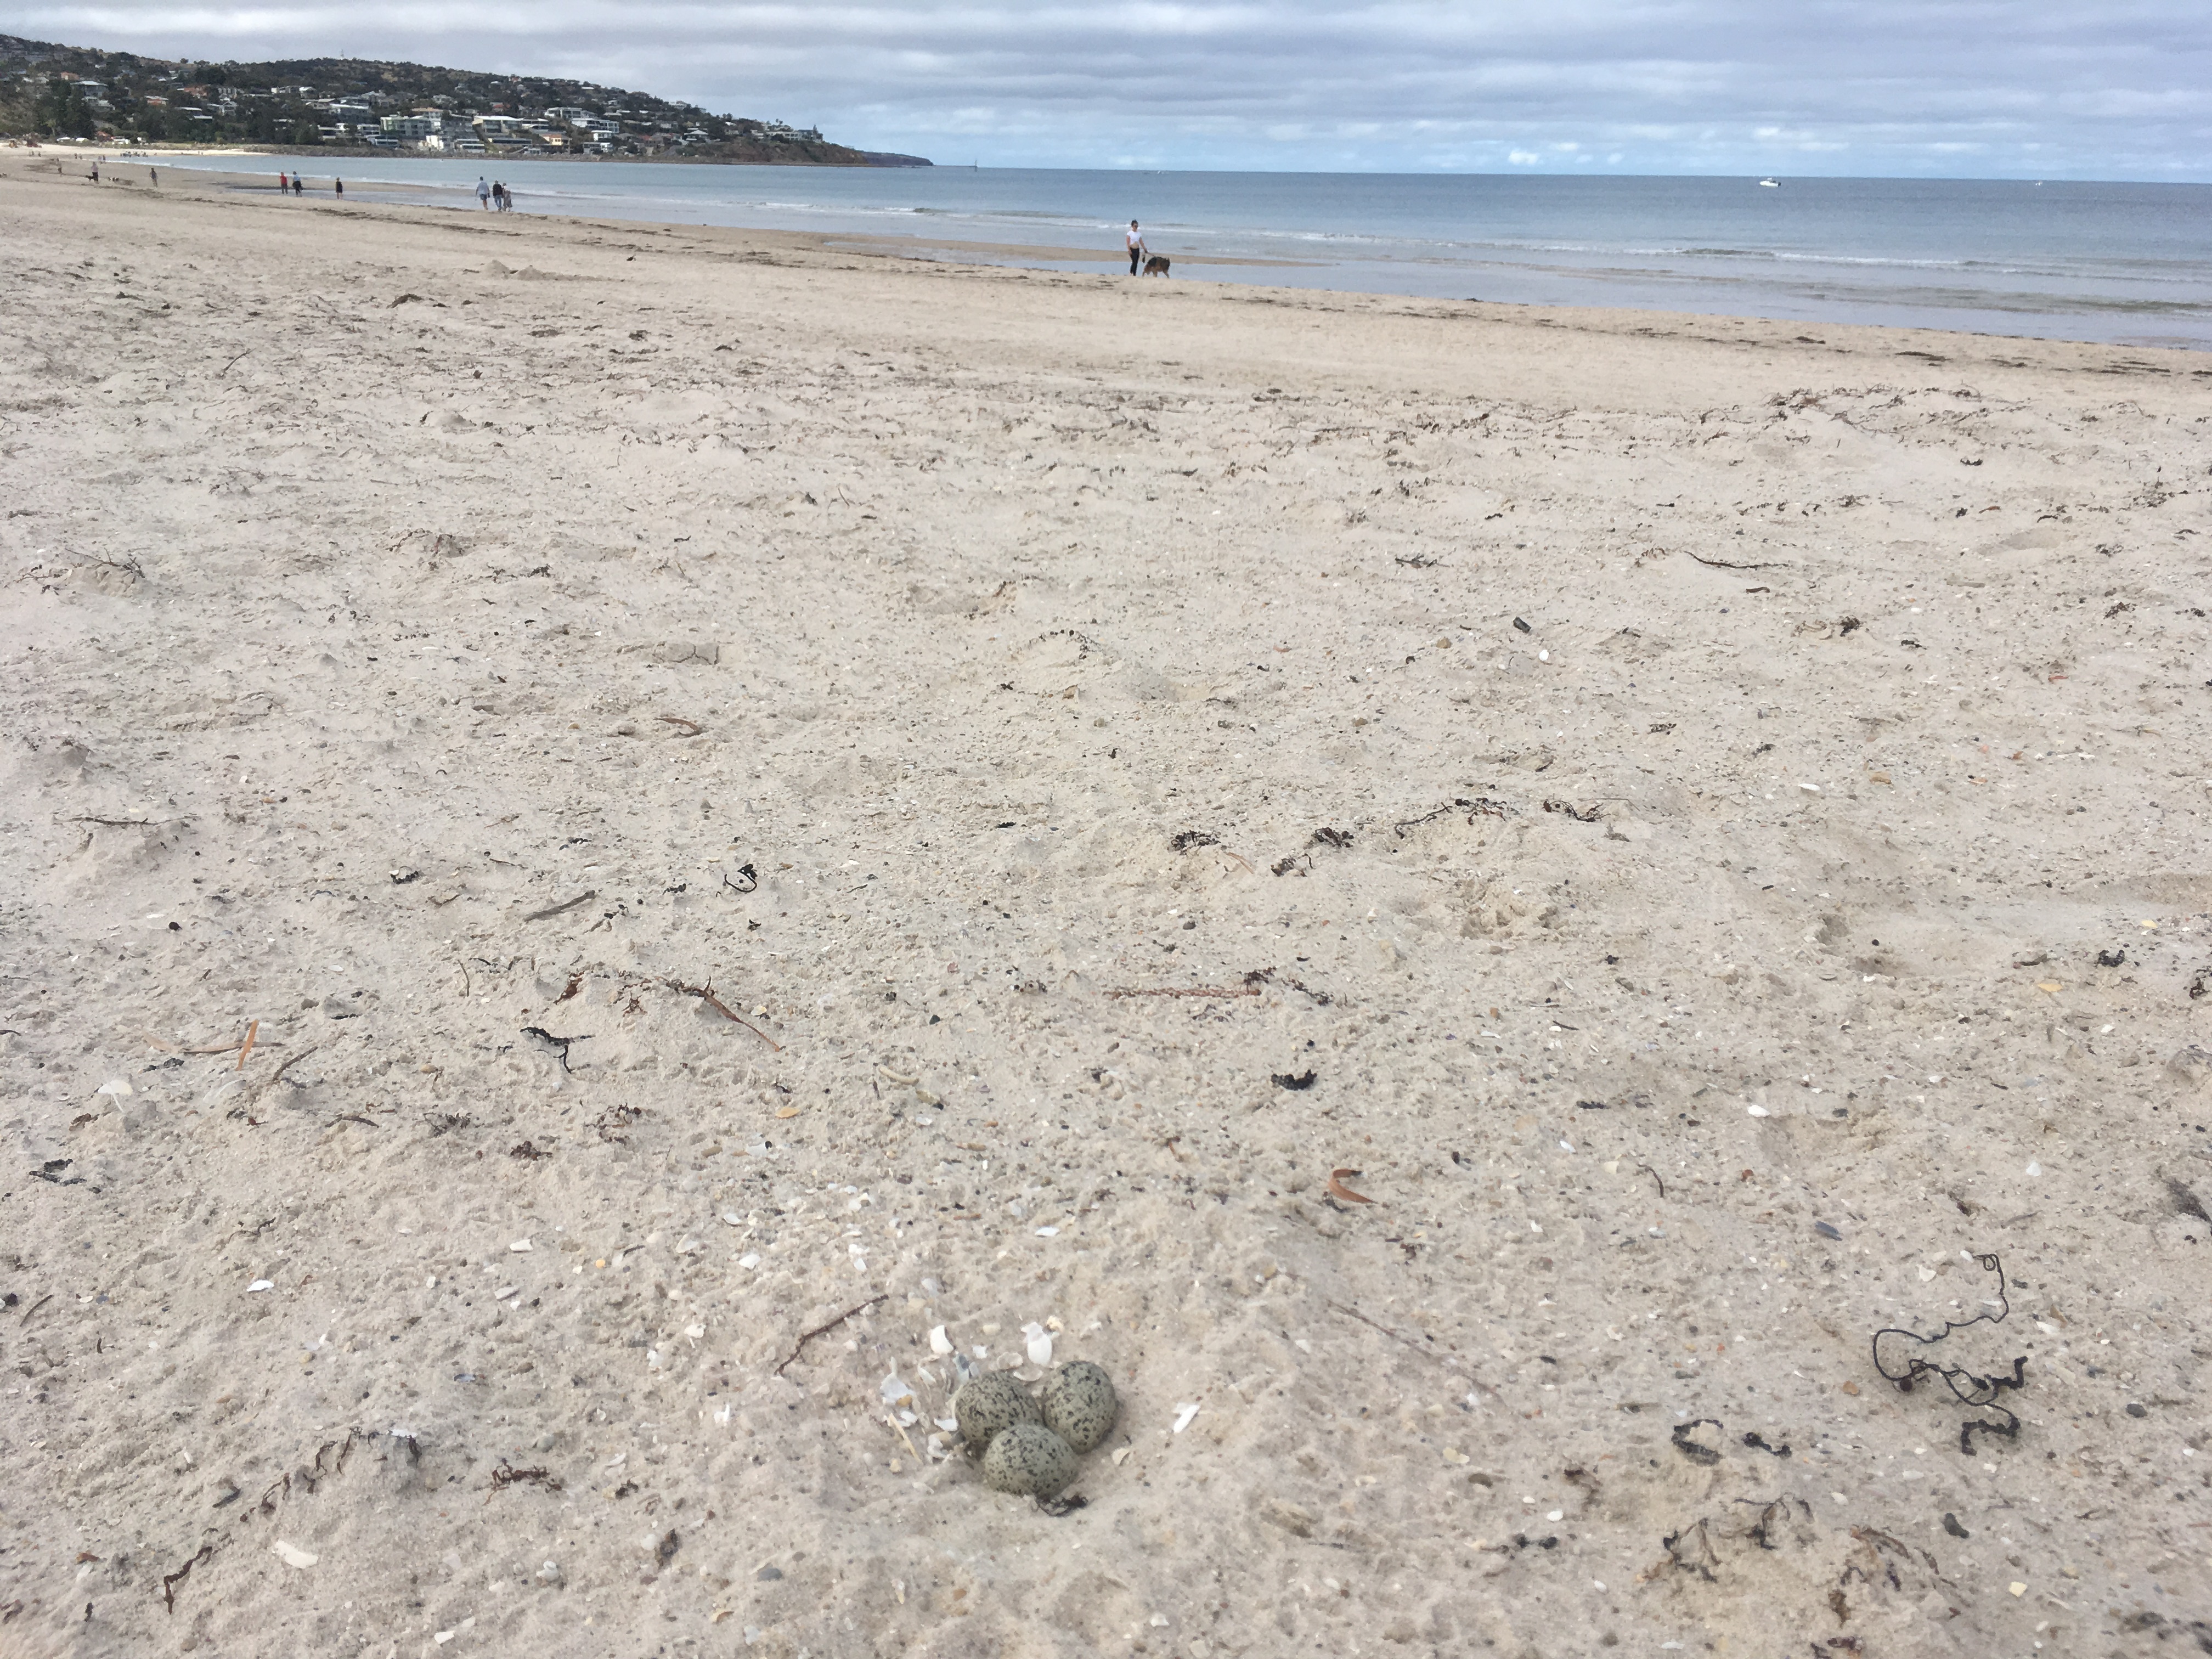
[17,0,2212,179]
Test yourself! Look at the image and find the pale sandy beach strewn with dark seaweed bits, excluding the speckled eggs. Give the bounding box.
[0,153,2212,1659]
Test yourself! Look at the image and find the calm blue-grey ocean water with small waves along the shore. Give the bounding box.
[156,157,2212,349]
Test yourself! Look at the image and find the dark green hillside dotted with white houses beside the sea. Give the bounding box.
[0,36,929,166]
